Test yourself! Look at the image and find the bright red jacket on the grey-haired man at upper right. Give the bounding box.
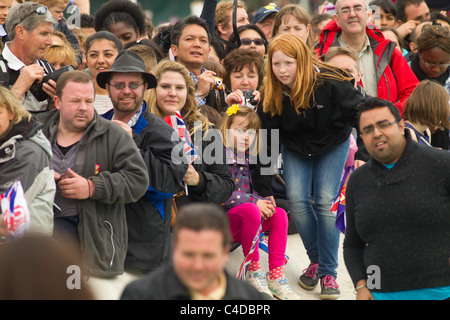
[315,20,419,115]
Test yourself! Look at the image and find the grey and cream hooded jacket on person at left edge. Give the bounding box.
[0,120,56,236]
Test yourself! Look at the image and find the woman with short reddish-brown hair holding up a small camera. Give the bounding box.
[223,48,264,109]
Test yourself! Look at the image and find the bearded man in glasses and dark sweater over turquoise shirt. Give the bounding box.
[343,98,450,300]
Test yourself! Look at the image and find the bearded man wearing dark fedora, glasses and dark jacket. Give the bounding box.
[97,50,187,272]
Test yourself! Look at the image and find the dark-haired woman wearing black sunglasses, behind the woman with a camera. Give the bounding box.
[225,24,268,58]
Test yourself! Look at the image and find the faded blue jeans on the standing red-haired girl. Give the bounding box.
[283,138,350,278]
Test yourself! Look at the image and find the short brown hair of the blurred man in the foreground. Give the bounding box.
[172,203,232,248]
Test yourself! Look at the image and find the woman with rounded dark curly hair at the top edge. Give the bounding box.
[94,0,147,45]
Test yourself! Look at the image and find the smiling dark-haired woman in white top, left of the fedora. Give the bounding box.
[86,31,122,114]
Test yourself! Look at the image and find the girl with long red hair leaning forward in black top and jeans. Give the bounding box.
[257,34,364,299]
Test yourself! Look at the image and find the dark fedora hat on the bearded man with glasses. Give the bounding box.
[97,50,156,89]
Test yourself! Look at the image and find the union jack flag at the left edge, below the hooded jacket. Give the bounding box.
[0,181,30,239]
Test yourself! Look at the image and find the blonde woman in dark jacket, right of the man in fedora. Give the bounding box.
[148,60,234,204]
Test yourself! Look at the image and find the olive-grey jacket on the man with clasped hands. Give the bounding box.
[38,111,149,276]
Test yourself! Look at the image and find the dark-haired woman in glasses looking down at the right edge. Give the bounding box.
[410,25,450,150]
